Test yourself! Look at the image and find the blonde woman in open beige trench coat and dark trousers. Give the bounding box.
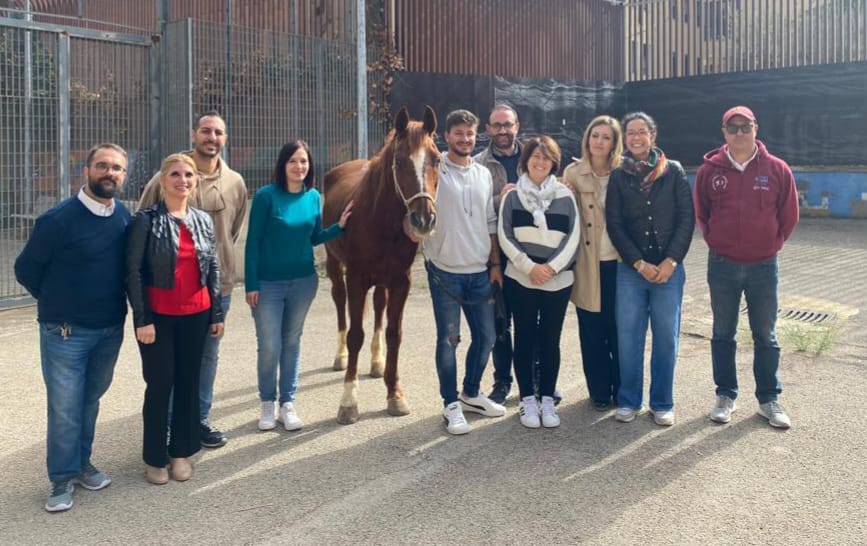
[563,116,623,411]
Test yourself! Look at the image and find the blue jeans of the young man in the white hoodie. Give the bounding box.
[428,264,497,405]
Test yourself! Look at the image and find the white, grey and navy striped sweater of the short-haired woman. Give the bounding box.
[497,182,580,292]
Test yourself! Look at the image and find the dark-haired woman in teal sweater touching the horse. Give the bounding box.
[244,140,352,430]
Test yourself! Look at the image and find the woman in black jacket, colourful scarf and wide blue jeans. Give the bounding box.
[605,112,695,426]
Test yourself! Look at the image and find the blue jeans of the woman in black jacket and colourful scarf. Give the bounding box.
[614,263,686,411]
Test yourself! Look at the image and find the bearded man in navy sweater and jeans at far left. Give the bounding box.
[15,143,130,512]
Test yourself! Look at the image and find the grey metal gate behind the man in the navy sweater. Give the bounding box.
[0,11,159,305]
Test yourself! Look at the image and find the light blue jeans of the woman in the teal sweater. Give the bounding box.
[253,275,319,404]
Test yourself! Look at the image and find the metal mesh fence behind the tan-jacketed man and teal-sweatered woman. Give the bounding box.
[162,20,357,198]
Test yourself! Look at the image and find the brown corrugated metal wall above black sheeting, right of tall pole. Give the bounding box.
[394,0,624,80]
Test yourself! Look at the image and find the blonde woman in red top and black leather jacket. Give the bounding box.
[127,154,223,484]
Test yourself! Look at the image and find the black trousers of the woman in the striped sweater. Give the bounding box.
[504,277,572,398]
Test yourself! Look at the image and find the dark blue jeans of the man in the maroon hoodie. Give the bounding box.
[707,252,782,404]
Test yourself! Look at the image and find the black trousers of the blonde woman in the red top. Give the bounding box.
[138,311,210,467]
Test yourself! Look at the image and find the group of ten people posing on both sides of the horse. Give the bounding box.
[15,105,798,512]
